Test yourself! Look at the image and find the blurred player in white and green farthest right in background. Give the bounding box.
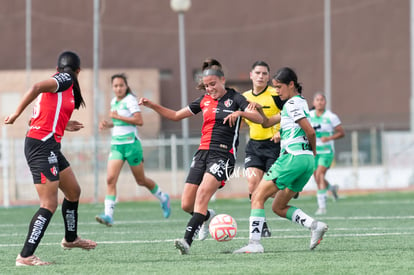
[310,92,345,215]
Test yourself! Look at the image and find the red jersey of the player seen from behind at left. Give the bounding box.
[27,73,75,142]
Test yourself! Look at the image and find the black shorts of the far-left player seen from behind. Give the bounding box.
[24,137,70,183]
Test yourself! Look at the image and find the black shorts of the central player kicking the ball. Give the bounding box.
[185,150,235,186]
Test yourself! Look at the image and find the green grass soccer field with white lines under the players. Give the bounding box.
[0,192,414,275]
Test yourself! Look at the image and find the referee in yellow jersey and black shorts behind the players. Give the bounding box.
[243,61,284,237]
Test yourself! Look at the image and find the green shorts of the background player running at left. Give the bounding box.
[108,139,143,166]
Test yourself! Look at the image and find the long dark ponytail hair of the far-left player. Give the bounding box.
[57,51,85,109]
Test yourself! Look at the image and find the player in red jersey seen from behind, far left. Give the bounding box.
[4,51,96,266]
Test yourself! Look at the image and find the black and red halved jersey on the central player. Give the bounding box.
[188,88,249,155]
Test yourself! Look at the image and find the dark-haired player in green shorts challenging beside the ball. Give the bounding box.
[234,67,328,253]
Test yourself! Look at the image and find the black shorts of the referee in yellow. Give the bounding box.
[244,139,280,172]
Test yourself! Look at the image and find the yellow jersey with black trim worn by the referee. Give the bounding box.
[243,86,283,140]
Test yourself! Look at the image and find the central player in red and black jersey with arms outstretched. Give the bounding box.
[140,59,263,254]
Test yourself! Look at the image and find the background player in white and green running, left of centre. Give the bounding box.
[96,74,171,226]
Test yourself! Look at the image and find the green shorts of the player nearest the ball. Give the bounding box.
[263,154,314,192]
